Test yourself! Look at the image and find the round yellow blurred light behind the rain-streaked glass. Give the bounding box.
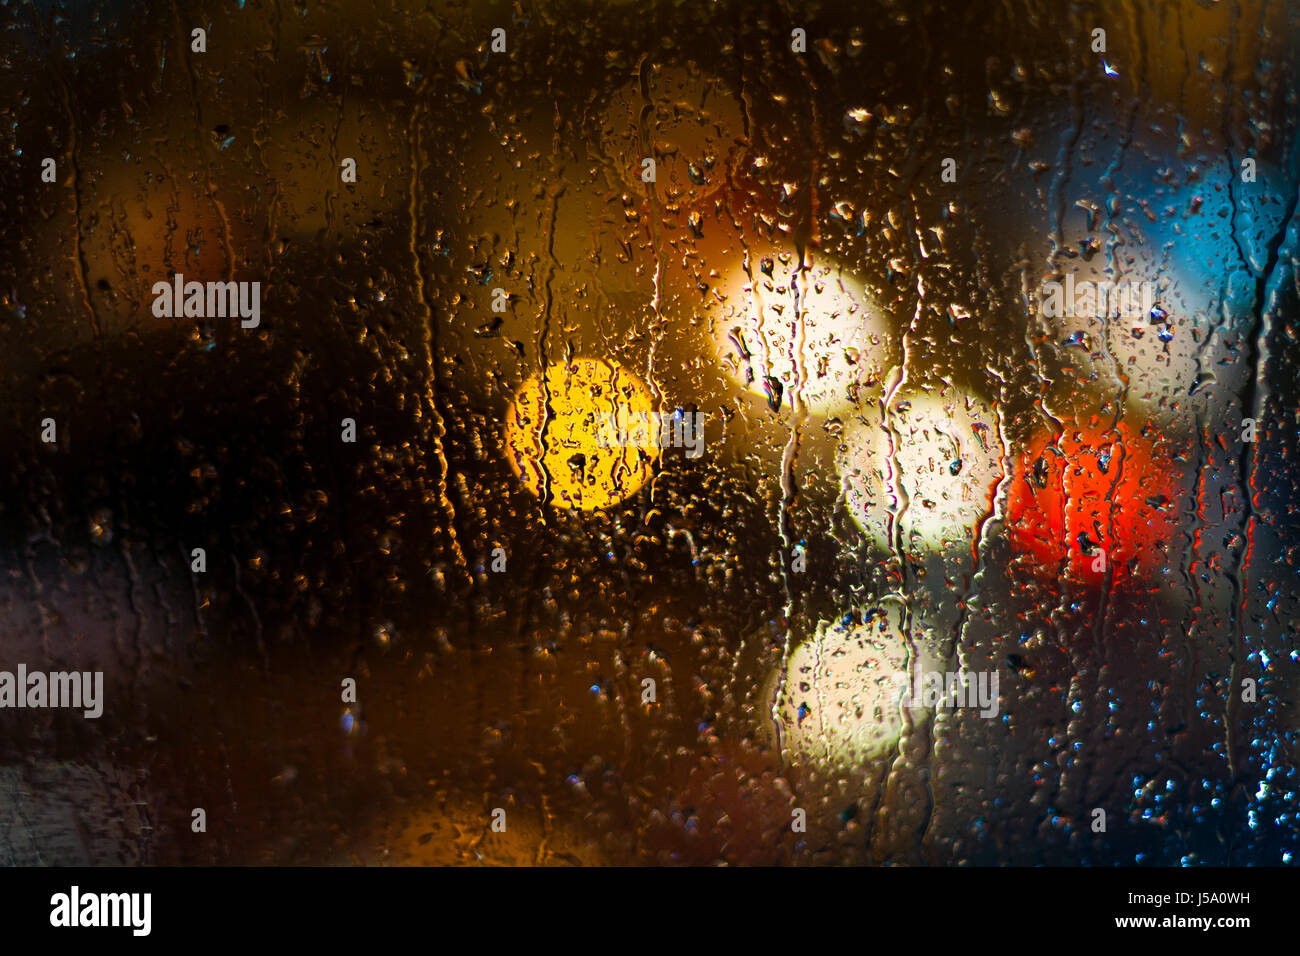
[504,359,659,511]
